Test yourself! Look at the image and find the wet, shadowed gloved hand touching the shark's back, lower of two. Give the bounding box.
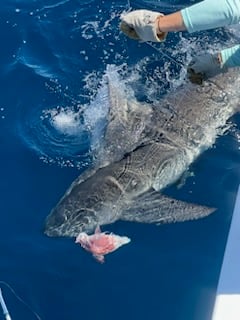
[187,53,226,84]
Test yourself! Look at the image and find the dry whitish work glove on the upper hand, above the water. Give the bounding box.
[120,10,167,42]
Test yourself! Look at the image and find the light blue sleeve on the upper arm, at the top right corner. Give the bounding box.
[181,0,240,33]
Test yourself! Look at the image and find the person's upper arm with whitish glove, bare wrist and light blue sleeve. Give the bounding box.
[120,0,240,42]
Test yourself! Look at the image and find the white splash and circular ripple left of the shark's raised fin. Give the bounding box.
[18,68,123,169]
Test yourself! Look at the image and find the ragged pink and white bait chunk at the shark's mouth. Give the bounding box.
[75,227,131,263]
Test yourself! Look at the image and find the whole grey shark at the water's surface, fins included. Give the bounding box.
[45,68,240,237]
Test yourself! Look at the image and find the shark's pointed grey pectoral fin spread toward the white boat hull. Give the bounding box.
[121,191,215,224]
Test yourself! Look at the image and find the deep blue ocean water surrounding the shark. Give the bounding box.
[0,0,240,320]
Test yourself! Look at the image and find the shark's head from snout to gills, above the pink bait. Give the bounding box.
[45,170,119,237]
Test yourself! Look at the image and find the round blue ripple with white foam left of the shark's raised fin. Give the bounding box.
[19,102,90,168]
